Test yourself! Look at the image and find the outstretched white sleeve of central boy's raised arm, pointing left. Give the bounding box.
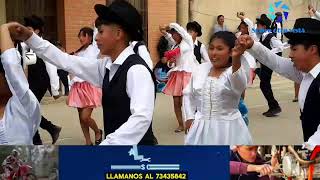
[26,33,106,87]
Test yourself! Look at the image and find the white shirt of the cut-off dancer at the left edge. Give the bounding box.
[0,48,41,145]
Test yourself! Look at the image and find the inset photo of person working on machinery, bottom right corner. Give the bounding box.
[230,145,320,180]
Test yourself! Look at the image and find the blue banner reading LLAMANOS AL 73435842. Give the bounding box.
[59,146,229,180]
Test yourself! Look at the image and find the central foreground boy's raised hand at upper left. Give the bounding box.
[8,22,33,41]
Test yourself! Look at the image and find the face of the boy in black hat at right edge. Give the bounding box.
[289,44,317,73]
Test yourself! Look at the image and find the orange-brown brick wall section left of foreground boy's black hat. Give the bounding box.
[57,0,106,52]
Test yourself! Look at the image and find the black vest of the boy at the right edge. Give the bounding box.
[300,73,320,141]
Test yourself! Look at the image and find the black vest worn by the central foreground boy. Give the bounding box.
[102,54,157,145]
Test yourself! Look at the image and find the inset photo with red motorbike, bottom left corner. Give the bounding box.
[0,145,59,180]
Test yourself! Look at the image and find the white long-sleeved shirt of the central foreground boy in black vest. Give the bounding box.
[26,34,155,145]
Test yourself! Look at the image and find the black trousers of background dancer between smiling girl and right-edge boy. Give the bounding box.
[256,64,279,109]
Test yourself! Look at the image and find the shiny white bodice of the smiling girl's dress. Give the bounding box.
[183,56,249,120]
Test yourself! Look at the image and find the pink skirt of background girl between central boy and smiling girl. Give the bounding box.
[163,71,191,96]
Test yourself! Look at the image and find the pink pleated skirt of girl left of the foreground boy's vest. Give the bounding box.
[67,81,102,108]
